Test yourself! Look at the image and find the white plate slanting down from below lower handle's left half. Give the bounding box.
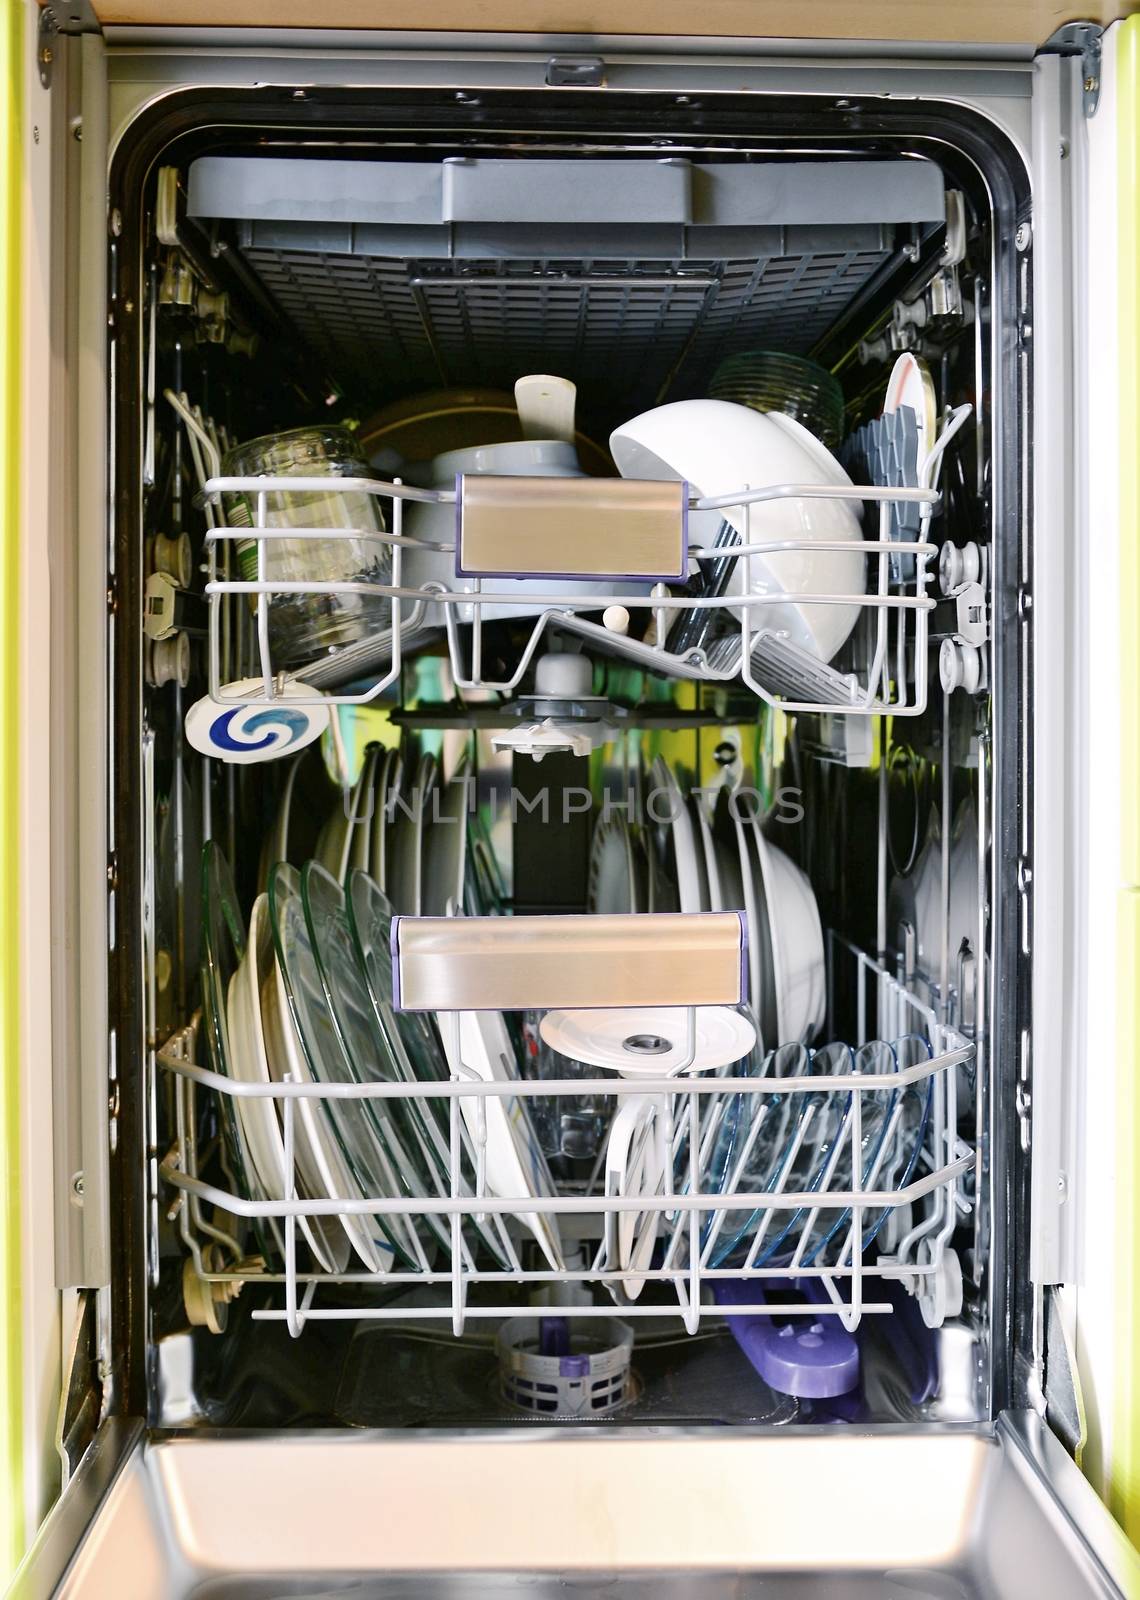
[440,1011,565,1272]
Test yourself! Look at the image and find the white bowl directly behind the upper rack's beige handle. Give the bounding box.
[403,438,648,627]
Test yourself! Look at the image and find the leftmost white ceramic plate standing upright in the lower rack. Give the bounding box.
[229,894,349,1272]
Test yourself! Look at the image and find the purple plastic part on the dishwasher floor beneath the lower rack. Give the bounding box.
[713,1278,860,1400]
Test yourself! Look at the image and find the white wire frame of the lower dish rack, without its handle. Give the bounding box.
[159,938,975,1336]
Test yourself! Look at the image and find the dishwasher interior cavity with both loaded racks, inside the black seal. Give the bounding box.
[110,90,1030,1429]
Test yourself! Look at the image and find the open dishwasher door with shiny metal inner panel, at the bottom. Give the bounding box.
[10,1413,1140,1600]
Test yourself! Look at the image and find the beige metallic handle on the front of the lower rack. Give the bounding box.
[392,912,748,1011]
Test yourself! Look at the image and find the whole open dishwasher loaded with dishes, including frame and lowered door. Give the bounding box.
[13,6,1137,1600]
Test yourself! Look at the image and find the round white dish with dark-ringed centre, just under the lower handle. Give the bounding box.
[538,1005,756,1078]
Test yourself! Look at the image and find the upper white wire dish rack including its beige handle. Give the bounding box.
[168,394,970,717]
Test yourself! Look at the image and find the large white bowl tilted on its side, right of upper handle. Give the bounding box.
[610,400,866,661]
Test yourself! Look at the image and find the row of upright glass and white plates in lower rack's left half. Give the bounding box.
[203,819,564,1274]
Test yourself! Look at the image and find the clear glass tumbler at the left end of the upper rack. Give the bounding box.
[221,427,392,669]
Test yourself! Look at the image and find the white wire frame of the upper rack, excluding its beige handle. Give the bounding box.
[184,395,970,717]
